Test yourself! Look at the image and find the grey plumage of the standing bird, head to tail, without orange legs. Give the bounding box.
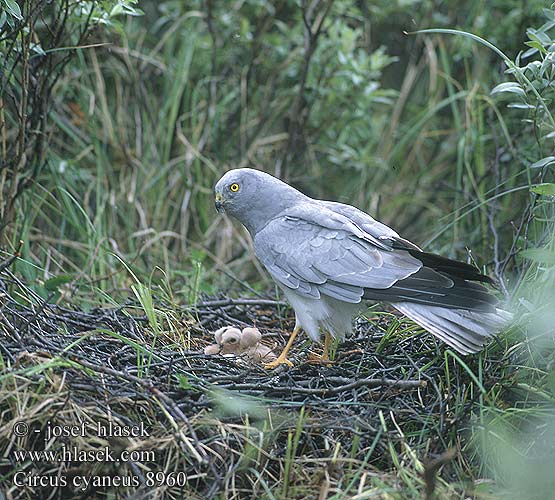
[215,169,510,354]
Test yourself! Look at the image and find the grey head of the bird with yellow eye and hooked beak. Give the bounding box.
[214,168,304,235]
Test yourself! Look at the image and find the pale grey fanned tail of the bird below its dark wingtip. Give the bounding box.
[392,302,512,354]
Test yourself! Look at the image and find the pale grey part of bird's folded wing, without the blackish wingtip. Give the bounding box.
[254,204,422,303]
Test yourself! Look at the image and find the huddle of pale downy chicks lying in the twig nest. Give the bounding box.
[204,326,277,363]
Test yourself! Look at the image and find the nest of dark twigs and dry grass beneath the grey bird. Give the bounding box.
[0,254,498,499]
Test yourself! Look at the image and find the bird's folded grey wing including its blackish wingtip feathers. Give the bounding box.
[254,202,495,309]
